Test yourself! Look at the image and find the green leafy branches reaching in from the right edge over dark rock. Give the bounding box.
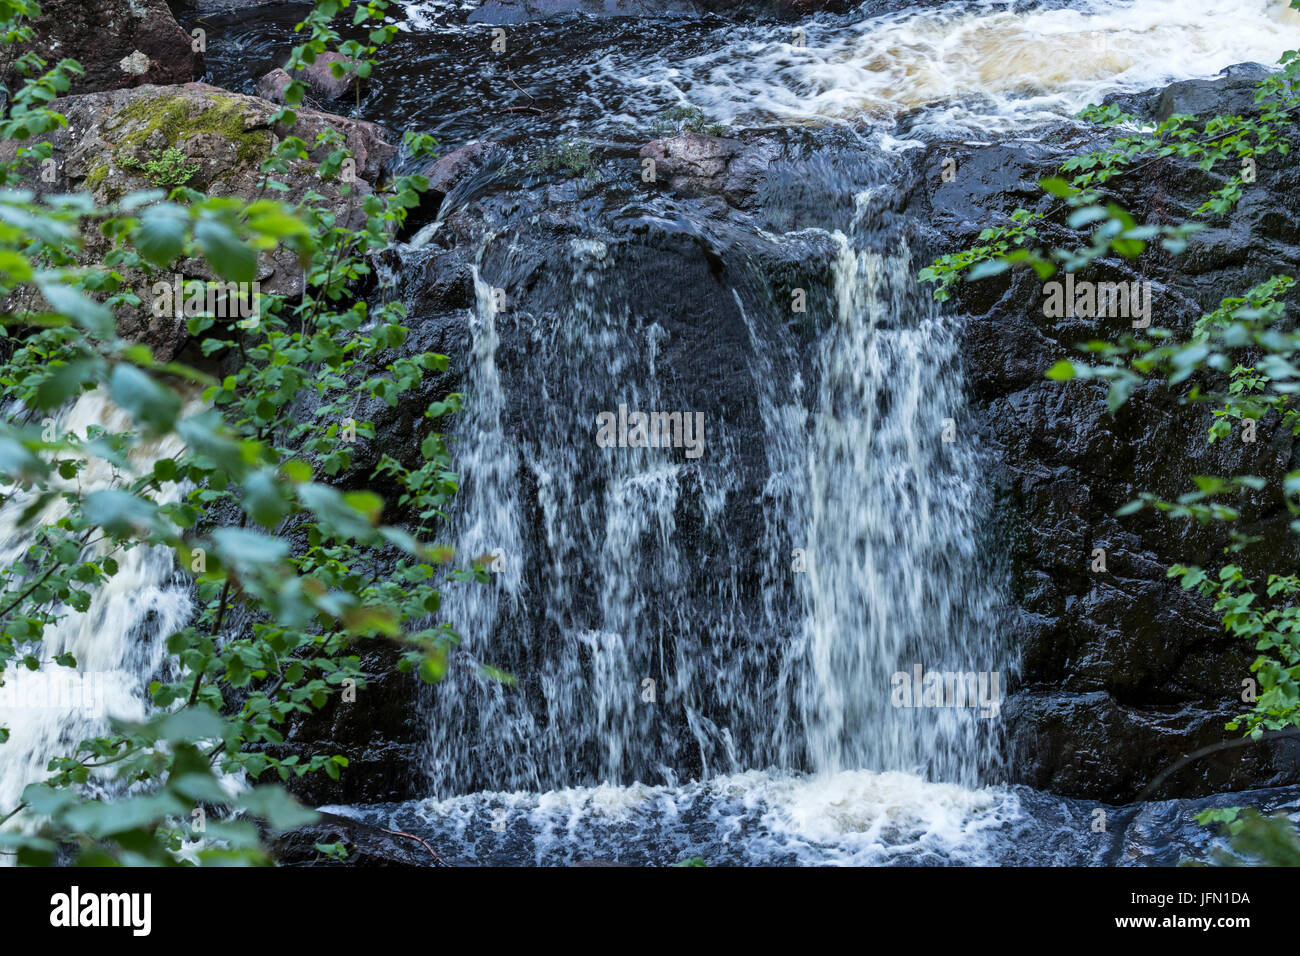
[919,0,1300,865]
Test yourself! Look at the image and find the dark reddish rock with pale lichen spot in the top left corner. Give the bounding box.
[5,0,203,94]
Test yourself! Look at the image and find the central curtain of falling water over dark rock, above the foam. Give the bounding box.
[421,170,1013,797]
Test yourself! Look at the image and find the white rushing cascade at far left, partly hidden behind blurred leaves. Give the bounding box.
[0,392,194,825]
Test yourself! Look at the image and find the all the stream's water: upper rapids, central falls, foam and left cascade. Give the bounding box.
[12,0,1300,865]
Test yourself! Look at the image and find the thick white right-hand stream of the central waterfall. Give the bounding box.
[792,234,1009,786]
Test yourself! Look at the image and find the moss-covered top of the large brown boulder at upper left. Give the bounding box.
[0,83,397,360]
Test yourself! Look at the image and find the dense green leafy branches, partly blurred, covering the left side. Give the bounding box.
[0,0,484,865]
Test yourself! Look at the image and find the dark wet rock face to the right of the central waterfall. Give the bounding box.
[914,69,1300,801]
